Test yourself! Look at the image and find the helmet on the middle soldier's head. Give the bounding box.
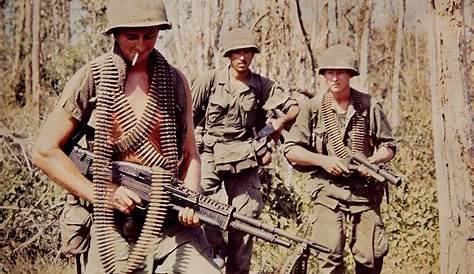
[222,28,260,57]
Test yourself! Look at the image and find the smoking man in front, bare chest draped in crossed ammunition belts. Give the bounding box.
[33,0,220,273]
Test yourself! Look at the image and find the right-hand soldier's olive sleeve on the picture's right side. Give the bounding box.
[369,101,397,152]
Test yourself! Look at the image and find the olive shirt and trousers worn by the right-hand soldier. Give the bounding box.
[285,89,395,273]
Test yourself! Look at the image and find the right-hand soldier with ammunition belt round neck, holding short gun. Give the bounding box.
[284,45,396,273]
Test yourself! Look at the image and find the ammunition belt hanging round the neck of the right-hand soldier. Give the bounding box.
[321,92,366,158]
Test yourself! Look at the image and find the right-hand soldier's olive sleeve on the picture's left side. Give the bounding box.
[284,100,316,153]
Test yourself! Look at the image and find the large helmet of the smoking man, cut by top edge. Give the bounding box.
[102,0,171,35]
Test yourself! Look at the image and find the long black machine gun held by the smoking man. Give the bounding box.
[69,146,330,253]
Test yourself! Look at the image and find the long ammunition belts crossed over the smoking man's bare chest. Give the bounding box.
[91,50,178,273]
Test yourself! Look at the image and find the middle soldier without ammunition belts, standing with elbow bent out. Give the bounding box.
[191,28,299,273]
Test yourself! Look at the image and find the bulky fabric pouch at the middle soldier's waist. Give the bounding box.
[214,141,258,174]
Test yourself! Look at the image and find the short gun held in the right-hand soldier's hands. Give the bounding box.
[347,153,402,186]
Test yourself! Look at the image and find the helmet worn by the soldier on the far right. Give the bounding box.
[318,45,359,76]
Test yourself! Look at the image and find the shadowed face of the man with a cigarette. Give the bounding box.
[114,27,159,63]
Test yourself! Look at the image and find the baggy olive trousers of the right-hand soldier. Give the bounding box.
[312,203,388,274]
